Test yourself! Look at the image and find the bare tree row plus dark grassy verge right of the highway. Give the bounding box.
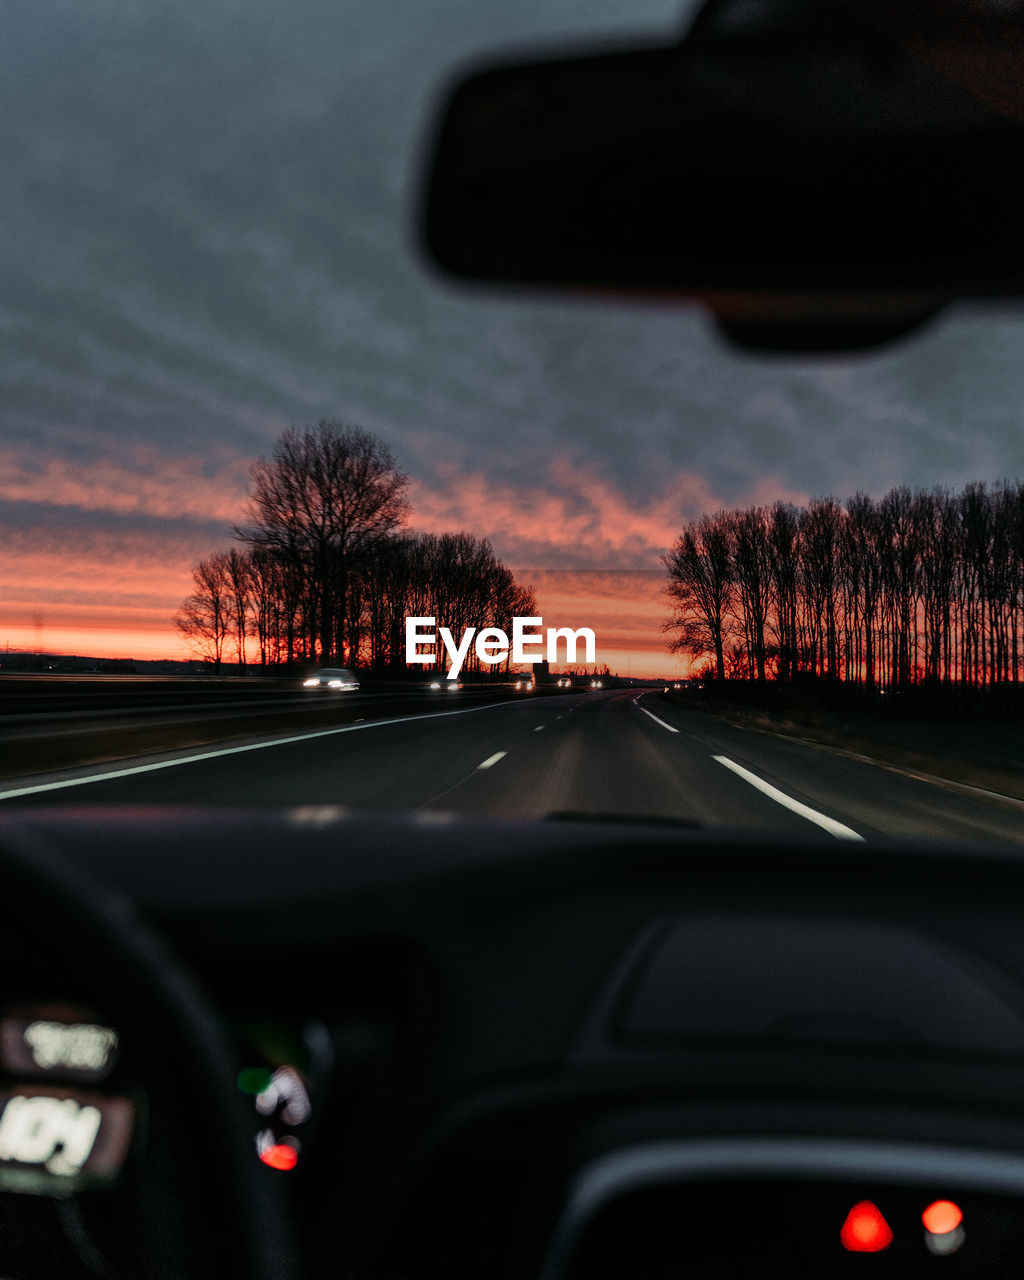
[664,481,1024,799]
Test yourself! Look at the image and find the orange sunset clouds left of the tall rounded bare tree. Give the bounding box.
[0,442,247,658]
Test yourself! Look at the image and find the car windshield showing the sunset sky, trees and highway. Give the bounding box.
[0,0,1024,840]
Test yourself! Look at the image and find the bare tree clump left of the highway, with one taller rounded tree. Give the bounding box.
[174,422,536,672]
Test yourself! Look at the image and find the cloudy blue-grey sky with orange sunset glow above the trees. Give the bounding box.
[0,0,1024,669]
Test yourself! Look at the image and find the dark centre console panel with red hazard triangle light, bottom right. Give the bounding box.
[560,1176,1024,1280]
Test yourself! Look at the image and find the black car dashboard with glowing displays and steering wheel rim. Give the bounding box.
[0,809,1024,1280]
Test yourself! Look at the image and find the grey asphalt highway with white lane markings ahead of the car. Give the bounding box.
[0,690,1024,842]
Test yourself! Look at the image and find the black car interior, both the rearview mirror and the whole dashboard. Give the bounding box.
[0,0,1024,1280]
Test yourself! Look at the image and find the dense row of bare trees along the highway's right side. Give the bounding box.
[664,481,1024,689]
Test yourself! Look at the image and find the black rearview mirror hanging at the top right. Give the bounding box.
[421,0,1024,348]
